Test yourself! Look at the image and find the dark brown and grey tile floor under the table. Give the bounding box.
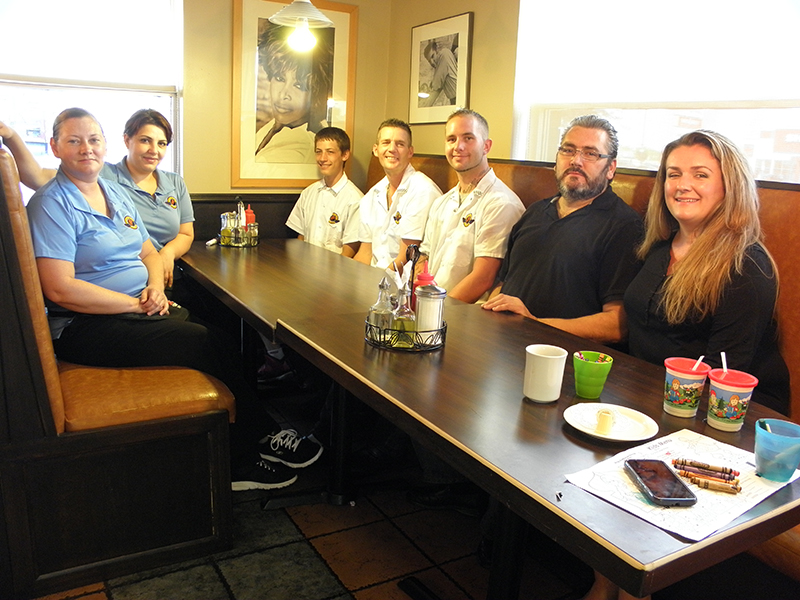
[31,370,800,600]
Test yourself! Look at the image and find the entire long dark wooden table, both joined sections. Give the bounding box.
[180,240,800,598]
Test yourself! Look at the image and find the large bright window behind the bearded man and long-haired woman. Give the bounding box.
[512,0,800,183]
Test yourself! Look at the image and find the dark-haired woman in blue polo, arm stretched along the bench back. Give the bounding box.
[0,109,194,287]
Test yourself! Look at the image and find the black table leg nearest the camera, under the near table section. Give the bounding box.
[486,505,528,600]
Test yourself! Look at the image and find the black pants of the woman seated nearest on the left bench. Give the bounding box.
[53,314,280,466]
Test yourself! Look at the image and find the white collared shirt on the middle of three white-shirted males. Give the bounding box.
[358,165,442,269]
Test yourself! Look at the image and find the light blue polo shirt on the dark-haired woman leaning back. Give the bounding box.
[100,158,194,250]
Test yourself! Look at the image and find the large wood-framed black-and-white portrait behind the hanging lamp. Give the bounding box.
[231,0,358,188]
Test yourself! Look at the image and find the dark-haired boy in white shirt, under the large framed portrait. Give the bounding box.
[286,127,364,258]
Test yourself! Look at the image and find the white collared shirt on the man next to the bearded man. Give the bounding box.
[420,169,525,290]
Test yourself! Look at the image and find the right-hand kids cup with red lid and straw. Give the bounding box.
[708,369,758,431]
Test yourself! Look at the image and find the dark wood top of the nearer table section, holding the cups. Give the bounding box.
[278,305,800,595]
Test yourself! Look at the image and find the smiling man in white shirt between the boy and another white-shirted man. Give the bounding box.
[355,119,442,271]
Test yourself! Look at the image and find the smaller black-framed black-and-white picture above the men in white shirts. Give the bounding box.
[408,12,472,123]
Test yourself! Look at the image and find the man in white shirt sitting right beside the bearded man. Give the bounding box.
[420,109,525,302]
